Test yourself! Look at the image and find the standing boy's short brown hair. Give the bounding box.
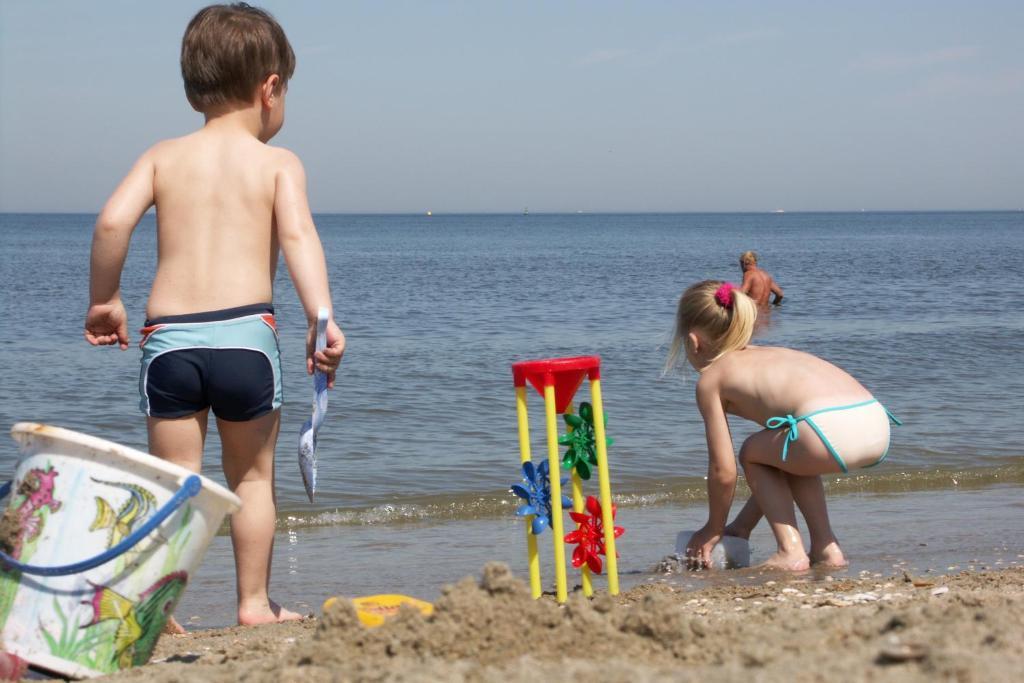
[181,2,295,112]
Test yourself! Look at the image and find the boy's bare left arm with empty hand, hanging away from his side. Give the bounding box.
[85,151,154,350]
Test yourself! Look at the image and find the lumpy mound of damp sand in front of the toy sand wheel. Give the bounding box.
[297,563,697,666]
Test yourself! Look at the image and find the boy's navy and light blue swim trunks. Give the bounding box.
[138,304,283,422]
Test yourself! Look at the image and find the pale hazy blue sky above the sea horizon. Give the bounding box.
[0,0,1024,213]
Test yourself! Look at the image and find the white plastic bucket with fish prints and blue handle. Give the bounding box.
[0,422,242,678]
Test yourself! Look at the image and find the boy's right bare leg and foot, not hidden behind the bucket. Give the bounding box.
[211,411,302,626]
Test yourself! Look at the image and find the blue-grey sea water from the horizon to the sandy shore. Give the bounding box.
[0,212,1024,626]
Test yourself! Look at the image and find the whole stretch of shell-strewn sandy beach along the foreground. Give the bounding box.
[90,563,1024,683]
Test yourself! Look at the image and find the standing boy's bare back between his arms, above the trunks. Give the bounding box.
[146,126,289,317]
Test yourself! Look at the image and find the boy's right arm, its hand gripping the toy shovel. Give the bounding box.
[273,150,345,388]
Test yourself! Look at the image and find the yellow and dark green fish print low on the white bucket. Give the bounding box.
[81,570,188,669]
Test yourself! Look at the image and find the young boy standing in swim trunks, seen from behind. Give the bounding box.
[85,4,345,625]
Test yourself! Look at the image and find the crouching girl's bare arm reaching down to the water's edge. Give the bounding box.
[687,376,736,568]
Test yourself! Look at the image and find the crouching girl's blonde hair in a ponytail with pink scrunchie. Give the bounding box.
[665,280,758,372]
